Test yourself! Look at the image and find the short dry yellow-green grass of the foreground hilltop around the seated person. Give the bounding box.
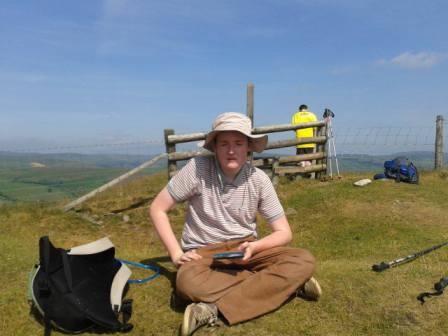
[0,172,448,336]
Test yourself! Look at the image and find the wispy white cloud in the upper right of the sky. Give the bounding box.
[378,52,448,69]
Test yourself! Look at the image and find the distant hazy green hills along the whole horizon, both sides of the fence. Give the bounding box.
[0,152,442,204]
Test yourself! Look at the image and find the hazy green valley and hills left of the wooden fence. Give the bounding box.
[0,152,166,204]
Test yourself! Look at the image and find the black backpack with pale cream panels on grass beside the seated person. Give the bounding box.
[29,236,133,335]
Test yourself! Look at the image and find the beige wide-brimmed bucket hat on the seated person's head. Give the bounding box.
[203,112,268,153]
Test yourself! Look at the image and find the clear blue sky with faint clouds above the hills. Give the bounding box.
[0,0,448,150]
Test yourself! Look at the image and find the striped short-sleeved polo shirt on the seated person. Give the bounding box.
[167,157,284,250]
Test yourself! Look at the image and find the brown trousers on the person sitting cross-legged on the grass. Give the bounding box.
[176,238,315,324]
